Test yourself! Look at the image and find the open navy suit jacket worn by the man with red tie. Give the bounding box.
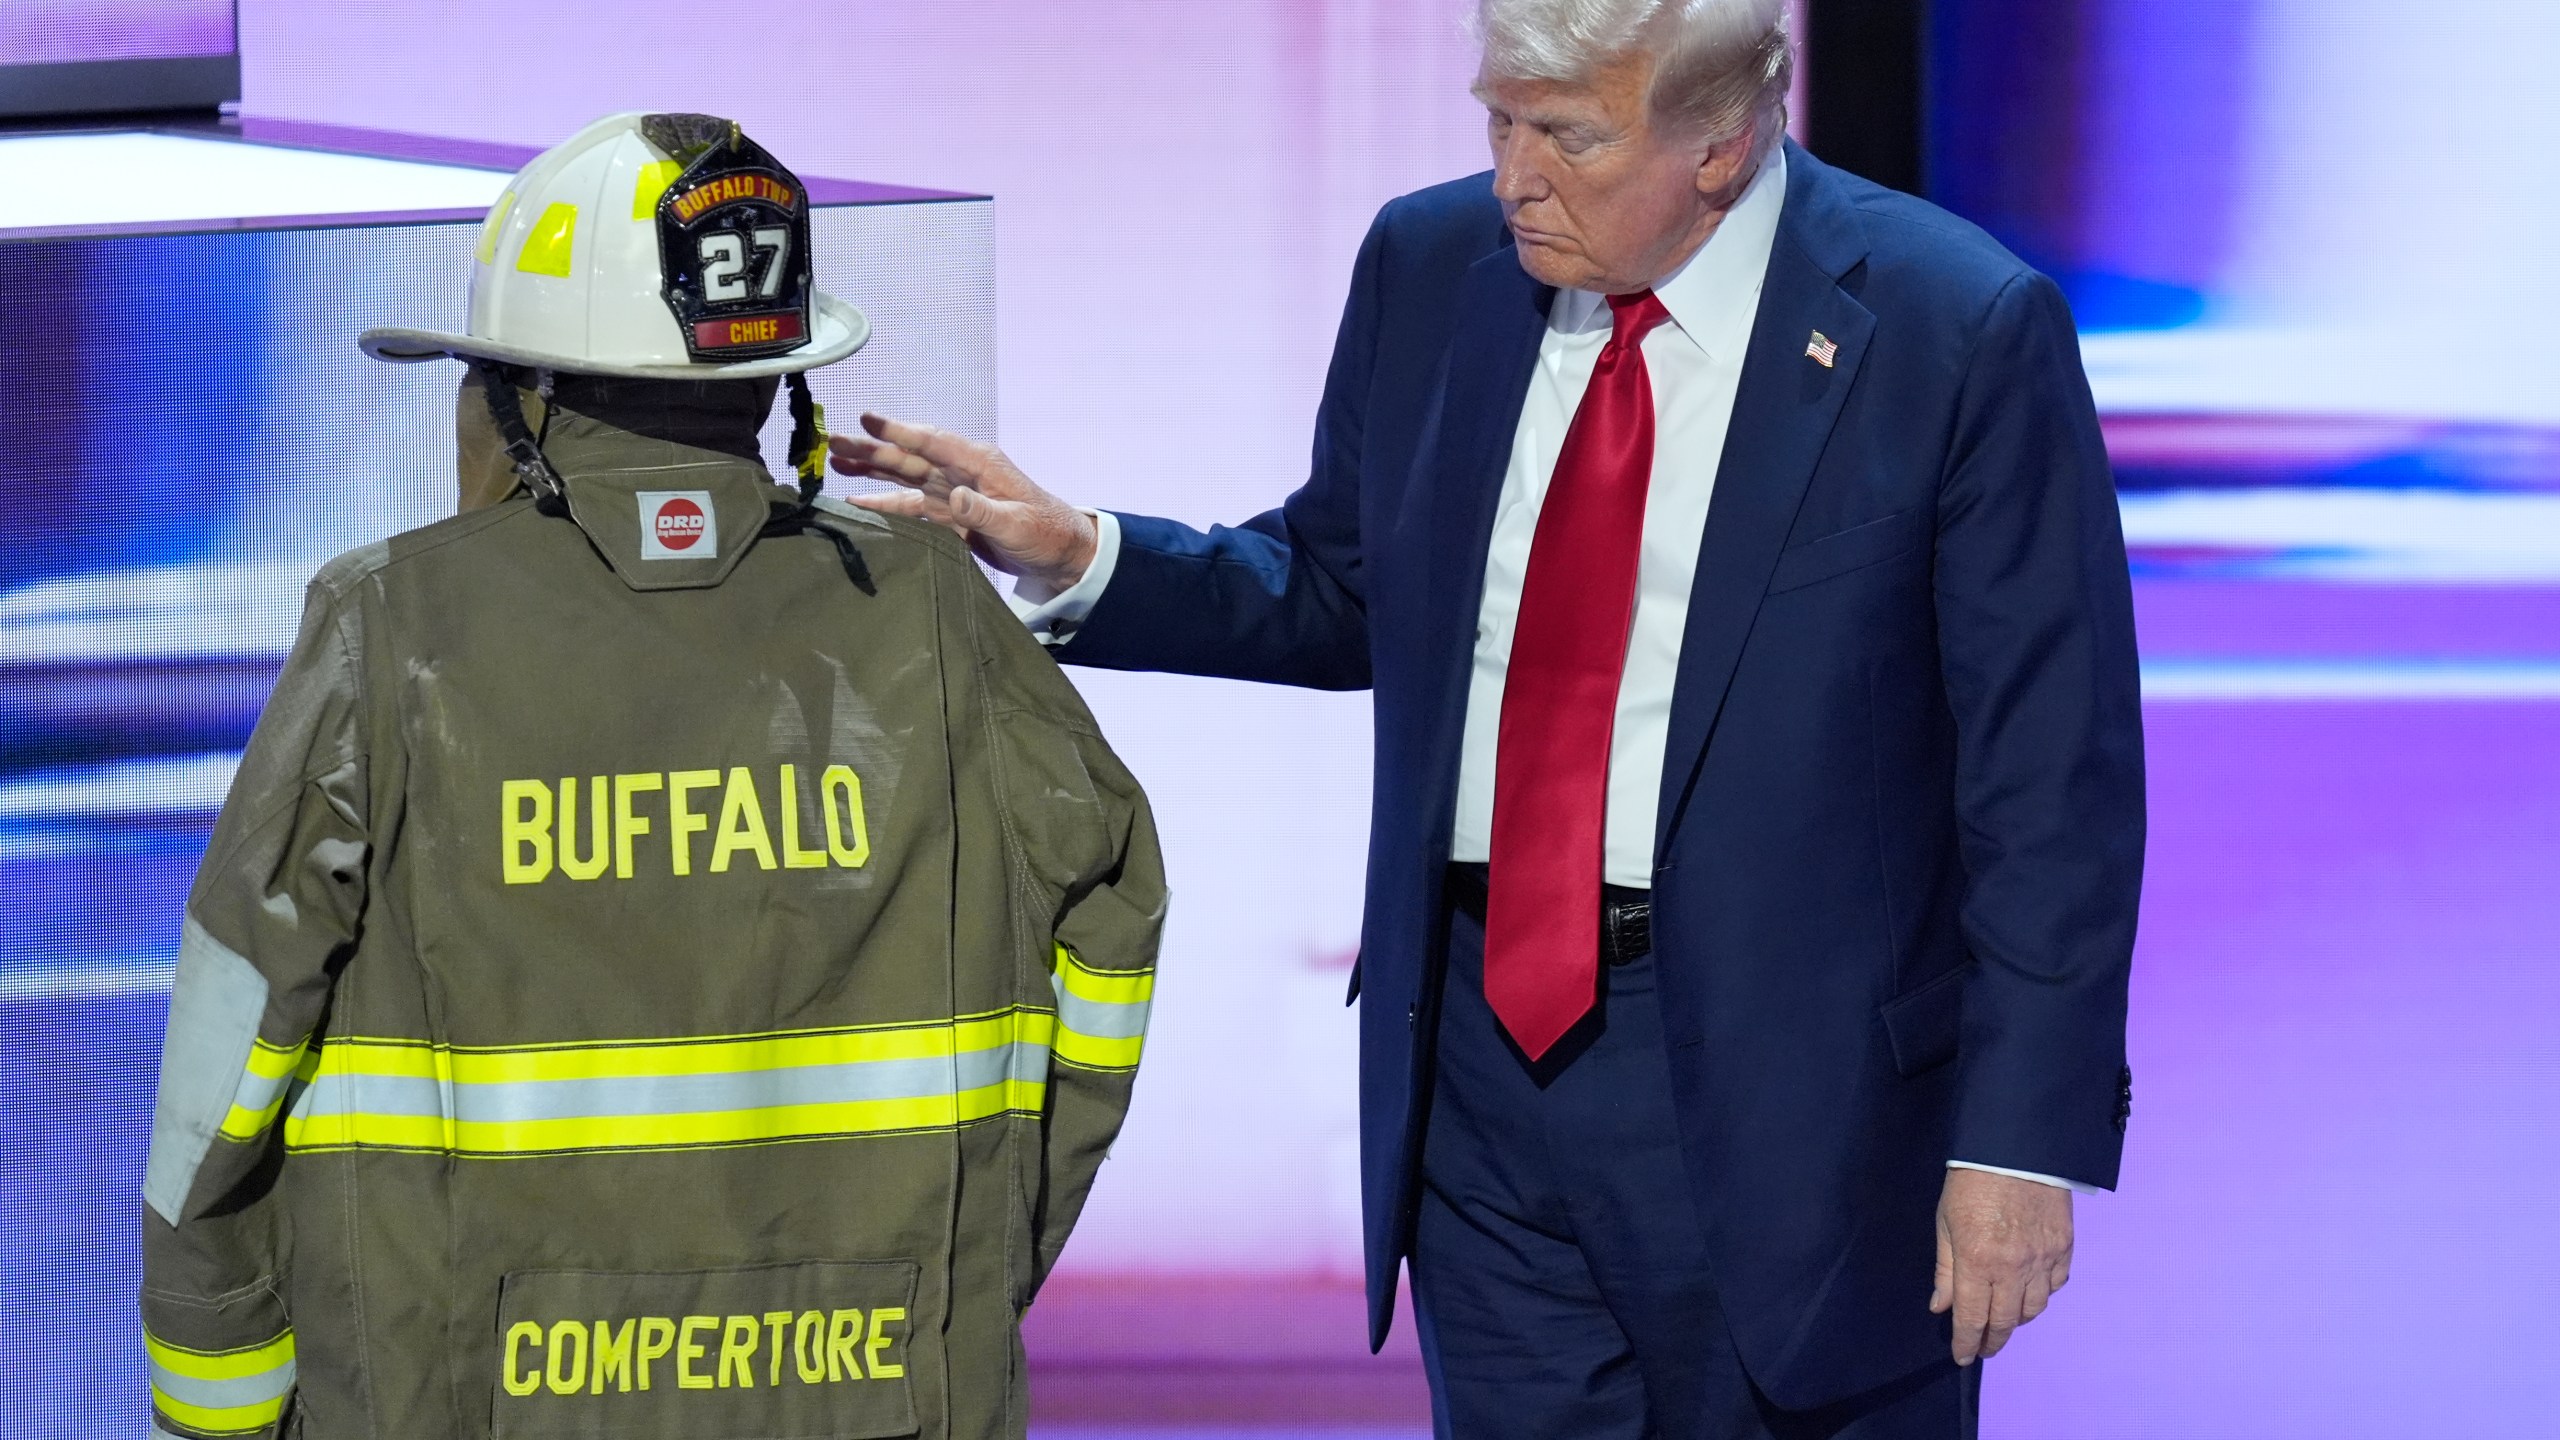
[1060,149,2143,1407]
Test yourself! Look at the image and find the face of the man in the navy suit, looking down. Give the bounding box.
[1475,51,1751,295]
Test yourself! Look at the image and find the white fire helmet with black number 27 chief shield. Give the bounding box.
[356,113,870,379]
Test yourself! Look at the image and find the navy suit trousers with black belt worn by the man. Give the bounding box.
[1411,891,1981,1440]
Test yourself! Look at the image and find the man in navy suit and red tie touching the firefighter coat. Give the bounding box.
[835,0,2143,1440]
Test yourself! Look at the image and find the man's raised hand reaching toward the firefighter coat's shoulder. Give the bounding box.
[827,413,1096,594]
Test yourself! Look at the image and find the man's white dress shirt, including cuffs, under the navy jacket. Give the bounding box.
[1011,151,2089,1191]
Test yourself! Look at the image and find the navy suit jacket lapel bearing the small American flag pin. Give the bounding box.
[1654,146,1876,863]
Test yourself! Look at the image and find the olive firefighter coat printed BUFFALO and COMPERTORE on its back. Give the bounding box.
[141,413,1165,1440]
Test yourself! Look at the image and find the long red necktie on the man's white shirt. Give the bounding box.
[1485,290,1672,1058]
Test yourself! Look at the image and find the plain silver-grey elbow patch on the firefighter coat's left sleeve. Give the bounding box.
[143,915,266,1225]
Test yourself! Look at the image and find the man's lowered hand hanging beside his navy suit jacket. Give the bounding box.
[1928,1168,2071,1366]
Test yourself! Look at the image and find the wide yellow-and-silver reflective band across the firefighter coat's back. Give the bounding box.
[284,1007,1057,1158]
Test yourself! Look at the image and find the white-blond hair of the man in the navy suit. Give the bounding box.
[1472,0,1795,156]
